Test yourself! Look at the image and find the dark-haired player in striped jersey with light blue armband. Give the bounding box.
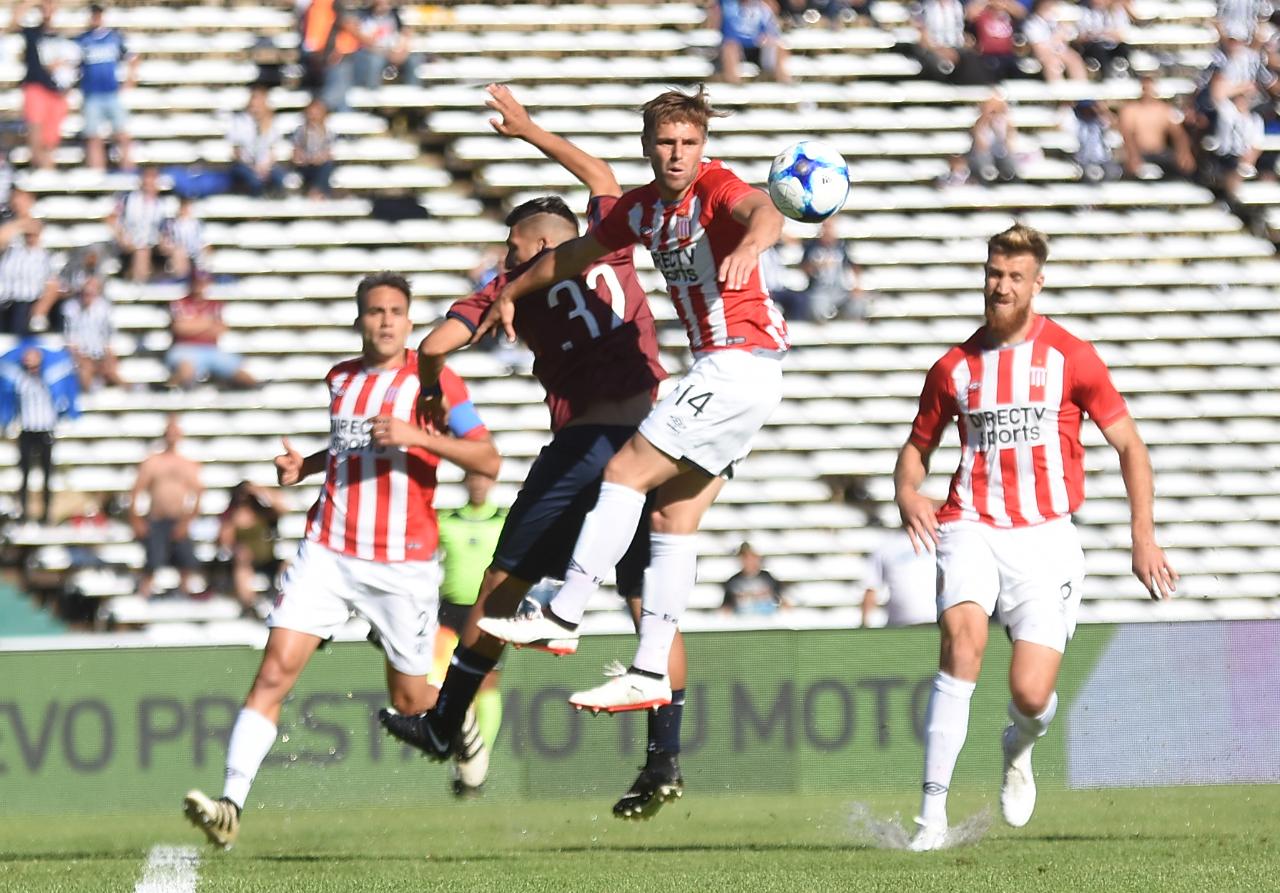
[183,273,500,847]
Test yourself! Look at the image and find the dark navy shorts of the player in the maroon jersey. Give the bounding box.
[493,425,649,596]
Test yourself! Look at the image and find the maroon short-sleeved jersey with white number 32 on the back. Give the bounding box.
[448,196,667,431]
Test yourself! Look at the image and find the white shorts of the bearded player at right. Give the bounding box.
[938,518,1084,651]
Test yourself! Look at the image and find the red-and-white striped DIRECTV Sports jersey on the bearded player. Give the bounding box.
[911,316,1128,527]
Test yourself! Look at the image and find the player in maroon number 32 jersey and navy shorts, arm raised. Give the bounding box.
[383,86,685,818]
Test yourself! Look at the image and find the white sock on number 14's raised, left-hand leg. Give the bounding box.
[550,481,644,624]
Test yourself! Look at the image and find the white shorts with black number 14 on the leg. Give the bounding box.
[640,351,782,477]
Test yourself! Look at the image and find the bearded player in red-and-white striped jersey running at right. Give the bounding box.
[895,224,1178,851]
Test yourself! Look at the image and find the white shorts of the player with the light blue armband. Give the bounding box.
[266,540,440,676]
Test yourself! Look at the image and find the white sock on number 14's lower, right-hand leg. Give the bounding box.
[632,533,698,676]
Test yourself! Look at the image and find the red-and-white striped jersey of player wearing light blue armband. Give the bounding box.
[306,351,488,562]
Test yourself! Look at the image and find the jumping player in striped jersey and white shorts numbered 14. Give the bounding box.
[477,90,790,711]
